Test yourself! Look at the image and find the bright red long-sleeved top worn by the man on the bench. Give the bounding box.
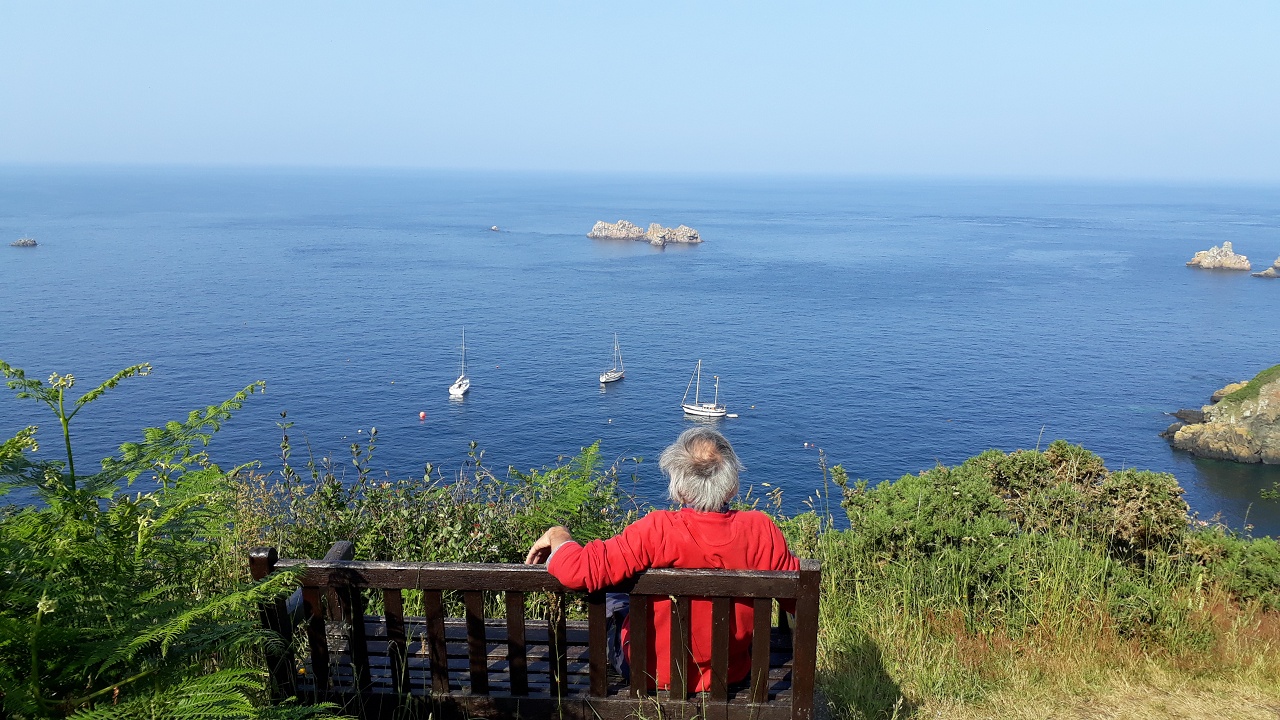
[547,509,800,692]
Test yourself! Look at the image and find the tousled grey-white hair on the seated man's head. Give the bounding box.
[658,428,746,512]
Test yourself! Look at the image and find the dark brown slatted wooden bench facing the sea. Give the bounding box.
[250,542,820,720]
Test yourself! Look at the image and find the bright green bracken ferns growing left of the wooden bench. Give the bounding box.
[0,361,327,719]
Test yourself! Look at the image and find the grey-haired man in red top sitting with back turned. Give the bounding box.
[525,427,800,692]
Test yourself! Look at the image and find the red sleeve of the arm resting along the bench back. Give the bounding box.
[547,512,662,592]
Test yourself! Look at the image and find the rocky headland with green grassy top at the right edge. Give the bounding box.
[1170,365,1280,465]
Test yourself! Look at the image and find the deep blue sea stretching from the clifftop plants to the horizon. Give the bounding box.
[0,167,1280,534]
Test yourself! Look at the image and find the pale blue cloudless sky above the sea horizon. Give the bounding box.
[0,0,1280,184]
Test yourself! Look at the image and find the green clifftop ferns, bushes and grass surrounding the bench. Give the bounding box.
[0,365,1280,717]
